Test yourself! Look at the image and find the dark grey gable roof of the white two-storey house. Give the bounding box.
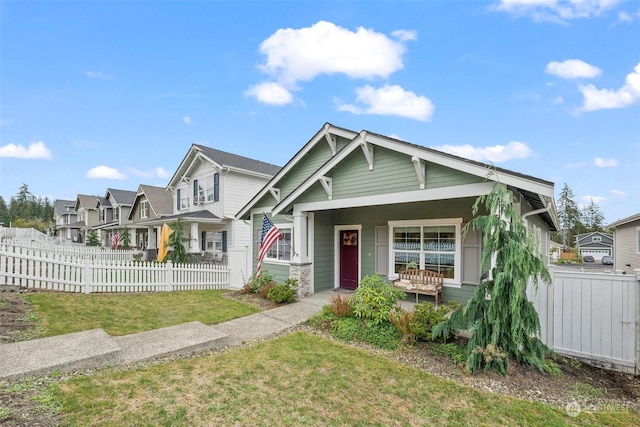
[167,144,281,188]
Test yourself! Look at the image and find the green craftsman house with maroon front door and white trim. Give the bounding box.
[237,123,558,302]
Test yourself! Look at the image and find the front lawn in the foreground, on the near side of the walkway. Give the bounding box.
[54,332,640,426]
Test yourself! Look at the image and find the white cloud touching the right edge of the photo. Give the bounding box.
[579,63,640,111]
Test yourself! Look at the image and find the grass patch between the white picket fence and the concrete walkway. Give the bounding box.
[24,291,259,337]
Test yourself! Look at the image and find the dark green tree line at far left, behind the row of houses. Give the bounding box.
[0,184,53,233]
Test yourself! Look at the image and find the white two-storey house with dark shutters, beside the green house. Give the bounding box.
[137,144,281,287]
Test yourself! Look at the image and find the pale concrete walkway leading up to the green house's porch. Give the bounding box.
[0,291,334,381]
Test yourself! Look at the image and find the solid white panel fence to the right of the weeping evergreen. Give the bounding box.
[527,268,640,374]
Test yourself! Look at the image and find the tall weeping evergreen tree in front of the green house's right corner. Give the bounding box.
[433,183,551,375]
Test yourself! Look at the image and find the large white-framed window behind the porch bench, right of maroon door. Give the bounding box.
[389,219,462,282]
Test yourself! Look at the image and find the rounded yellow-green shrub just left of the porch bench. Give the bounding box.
[349,274,406,323]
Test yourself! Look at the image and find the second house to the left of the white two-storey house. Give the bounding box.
[93,188,137,247]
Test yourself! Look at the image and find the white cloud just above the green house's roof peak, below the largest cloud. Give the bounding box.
[338,85,434,122]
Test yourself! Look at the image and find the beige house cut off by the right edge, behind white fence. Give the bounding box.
[607,213,640,273]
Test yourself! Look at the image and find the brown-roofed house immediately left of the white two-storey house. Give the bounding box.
[127,184,173,250]
